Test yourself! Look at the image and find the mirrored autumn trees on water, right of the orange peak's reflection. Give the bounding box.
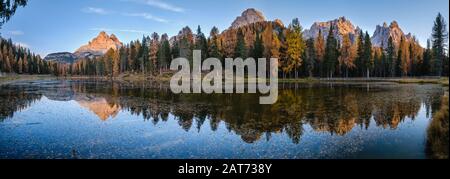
[68,83,441,143]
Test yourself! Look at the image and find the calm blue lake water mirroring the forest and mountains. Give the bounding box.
[0,80,445,159]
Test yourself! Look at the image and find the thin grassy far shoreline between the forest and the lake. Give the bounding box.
[0,74,449,86]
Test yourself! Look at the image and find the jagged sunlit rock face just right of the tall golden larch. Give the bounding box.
[303,17,359,42]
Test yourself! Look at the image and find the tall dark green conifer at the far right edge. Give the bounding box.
[431,13,448,76]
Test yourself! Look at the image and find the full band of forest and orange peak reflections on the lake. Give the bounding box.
[0,81,443,143]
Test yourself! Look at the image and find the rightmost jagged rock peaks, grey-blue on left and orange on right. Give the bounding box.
[372,21,411,49]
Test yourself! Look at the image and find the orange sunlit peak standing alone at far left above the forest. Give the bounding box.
[74,32,123,58]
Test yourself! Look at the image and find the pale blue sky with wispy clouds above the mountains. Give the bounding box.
[0,0,449,56]
